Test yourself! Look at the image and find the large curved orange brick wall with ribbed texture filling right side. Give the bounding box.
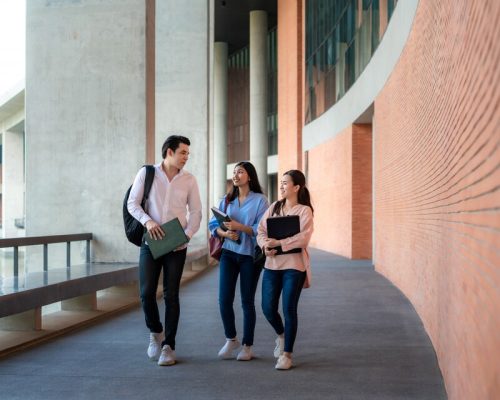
[374,0,500,400]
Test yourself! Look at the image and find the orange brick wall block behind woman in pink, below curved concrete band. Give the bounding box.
[308,125,372,258]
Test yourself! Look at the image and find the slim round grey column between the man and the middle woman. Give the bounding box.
[212,42,227,205]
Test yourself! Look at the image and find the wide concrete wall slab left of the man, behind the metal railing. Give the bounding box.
[26,0,145,261]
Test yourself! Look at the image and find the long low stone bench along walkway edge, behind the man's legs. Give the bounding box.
[0,246,209,331]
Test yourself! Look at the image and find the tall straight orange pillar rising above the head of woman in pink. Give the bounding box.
[277,0,303,176]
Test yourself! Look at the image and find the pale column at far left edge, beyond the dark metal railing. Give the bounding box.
[2,131,24,238]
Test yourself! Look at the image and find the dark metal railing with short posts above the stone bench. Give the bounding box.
[0,233,92,276]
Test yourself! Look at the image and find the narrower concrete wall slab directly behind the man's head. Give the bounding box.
[155,0,213,248]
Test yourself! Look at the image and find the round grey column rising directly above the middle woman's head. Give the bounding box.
[250,11,268,190]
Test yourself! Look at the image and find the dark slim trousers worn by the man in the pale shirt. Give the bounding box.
[139,243,187,350]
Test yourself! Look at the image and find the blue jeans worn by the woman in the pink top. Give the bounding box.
[262,269,306,353]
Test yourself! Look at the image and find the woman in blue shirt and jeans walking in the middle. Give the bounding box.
[208,161,269,361]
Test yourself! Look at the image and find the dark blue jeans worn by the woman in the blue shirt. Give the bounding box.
[219,249,262,346]
